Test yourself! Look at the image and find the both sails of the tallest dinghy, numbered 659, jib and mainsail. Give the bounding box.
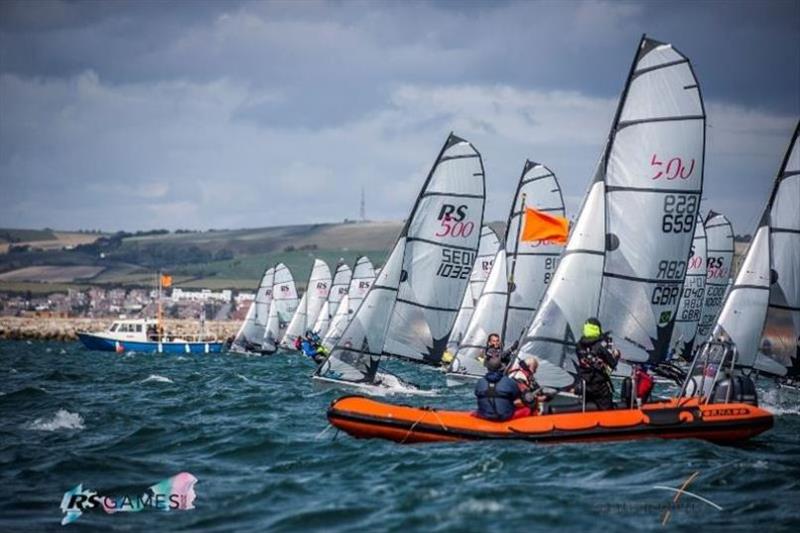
[518,37,705,388]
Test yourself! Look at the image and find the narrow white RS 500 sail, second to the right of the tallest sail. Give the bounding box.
[697,211,734,341]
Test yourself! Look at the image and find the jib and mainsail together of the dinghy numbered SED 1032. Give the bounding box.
[317,134,485,383]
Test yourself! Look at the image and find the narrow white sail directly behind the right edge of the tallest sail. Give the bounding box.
[670,217,706,359]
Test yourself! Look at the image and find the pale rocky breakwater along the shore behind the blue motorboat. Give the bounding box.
[0,317,240,342]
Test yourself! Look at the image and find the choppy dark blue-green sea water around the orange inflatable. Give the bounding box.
[0,342,800,531]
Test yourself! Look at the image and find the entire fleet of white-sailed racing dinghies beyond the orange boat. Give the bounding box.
[222,36,800,424]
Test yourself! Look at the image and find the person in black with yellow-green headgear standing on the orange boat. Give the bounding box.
[575,318,620,410]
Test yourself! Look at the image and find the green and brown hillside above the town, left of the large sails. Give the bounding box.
[0,222,402,292]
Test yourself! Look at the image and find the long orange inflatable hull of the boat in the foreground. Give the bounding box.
[328,396,773,444]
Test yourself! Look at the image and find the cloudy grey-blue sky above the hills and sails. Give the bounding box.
[0,0,800,234]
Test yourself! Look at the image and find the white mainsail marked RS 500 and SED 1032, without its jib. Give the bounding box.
[383,135,485,365]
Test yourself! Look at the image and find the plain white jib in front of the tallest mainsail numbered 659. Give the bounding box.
[518,181,605,387]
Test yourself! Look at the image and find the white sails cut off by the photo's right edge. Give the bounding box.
[713,123,800,368]
